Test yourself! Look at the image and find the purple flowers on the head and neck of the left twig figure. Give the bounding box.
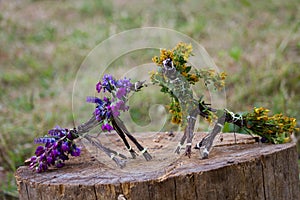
[87,74,133,131]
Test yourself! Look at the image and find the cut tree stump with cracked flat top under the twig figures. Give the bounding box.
[15,133,300,200]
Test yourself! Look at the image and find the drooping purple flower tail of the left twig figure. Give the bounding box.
[30,126,80,172]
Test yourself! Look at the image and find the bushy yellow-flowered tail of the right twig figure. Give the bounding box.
[243,107,299,144]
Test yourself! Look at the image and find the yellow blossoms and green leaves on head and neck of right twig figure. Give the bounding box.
[150,42,226,124]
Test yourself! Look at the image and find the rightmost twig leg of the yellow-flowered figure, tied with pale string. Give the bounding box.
[196,113,226,159]
